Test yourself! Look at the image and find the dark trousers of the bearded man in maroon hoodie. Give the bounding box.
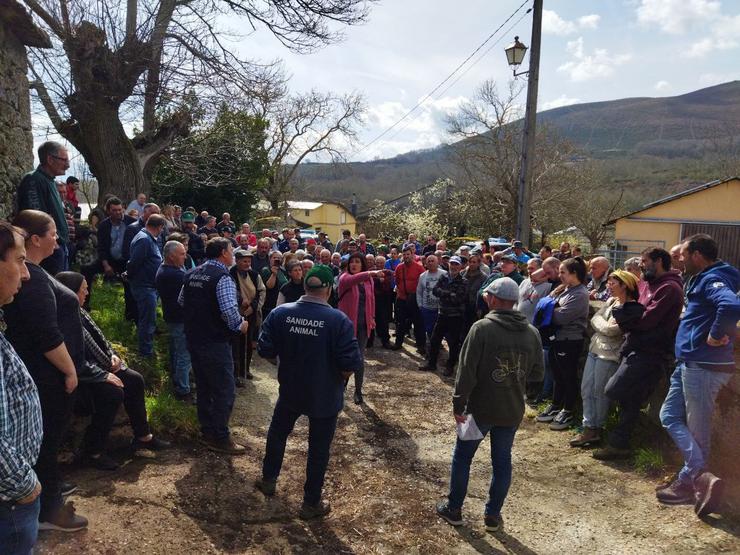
[604,352,667,449]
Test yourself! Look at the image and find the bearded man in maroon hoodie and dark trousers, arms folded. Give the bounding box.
[593,248,683,461]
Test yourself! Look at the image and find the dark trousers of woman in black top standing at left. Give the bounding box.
[33,381,74,521]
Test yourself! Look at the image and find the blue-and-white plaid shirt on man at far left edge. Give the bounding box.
[0,328,43,501]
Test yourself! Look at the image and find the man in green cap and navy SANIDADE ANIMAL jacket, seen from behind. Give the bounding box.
[256,264,362,519]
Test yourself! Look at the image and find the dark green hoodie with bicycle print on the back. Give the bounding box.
[452,310,545,427]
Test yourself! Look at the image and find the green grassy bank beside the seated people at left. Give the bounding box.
[90,279,198,437]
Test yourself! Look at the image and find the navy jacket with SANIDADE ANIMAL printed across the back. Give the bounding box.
[258,296,362,418]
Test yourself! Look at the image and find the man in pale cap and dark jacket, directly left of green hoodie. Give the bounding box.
[419,256,468,376]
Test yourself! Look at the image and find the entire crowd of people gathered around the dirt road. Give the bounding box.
[0,143,740,553]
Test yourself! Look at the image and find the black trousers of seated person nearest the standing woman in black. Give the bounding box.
[75,382,123,455]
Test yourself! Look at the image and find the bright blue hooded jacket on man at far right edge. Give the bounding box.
[676,260,740,371]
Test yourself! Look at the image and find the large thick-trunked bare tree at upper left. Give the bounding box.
[24,0,373,204]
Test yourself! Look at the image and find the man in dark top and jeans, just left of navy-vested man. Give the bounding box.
[155,241,192,402]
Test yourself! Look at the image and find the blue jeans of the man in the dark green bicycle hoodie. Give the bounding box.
[447,425,517,516]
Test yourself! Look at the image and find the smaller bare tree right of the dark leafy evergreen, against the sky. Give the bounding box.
[253,90,365,215]
